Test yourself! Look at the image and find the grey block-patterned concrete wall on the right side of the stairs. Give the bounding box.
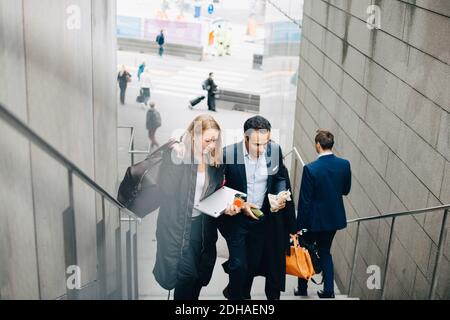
[294,0,450,299]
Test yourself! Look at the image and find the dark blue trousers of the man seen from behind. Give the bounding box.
[298,230,336,294]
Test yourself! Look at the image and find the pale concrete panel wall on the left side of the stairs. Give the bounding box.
[0,0,118,299]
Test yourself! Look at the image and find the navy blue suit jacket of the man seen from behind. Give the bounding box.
[297,154,352,232]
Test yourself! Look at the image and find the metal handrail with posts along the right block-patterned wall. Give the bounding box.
[285,147,450,300]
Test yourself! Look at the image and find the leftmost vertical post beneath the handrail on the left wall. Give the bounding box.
[62,169,81,300]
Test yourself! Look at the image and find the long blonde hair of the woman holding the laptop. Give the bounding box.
[183,114,222,167]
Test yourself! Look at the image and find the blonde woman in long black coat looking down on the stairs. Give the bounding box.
[153,115,223,300]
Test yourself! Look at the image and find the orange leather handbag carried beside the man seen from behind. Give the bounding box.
[286,235,314,280]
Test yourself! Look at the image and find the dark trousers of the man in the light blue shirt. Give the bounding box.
[218,214,280,300]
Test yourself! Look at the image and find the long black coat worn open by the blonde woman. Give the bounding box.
[153,145,223,290]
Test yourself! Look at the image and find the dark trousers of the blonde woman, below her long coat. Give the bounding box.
[174,215,204,300]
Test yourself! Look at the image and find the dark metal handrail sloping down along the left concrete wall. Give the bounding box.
[0,104,141,221]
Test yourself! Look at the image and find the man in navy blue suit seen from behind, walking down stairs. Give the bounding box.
[294,130,352,298]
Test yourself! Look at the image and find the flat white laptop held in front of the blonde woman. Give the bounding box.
[194,187,247,218]
